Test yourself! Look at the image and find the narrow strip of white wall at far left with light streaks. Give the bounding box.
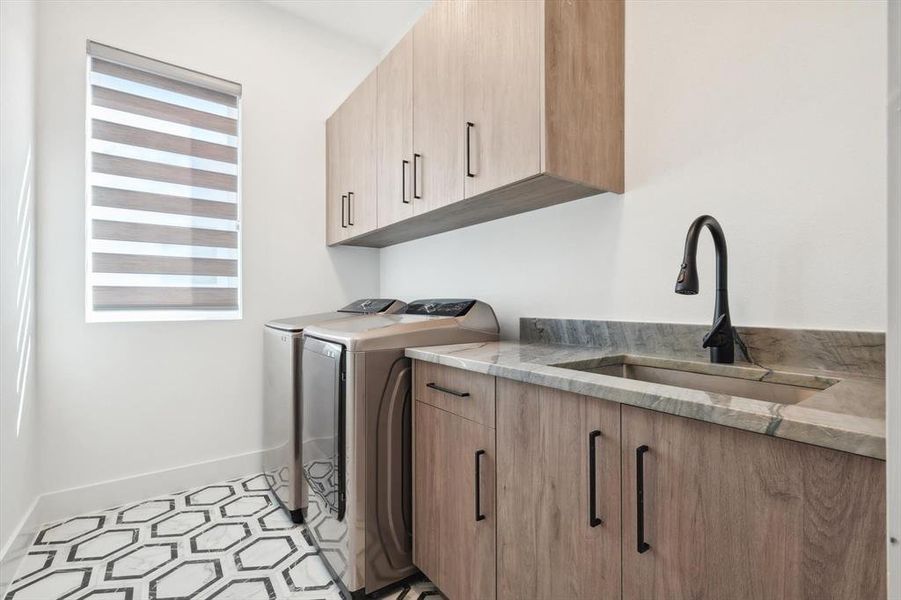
[0,1,38,580]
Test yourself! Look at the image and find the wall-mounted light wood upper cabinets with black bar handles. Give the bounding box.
[329,0,624,247]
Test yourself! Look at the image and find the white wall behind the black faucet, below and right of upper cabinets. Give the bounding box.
[381,0,886,337]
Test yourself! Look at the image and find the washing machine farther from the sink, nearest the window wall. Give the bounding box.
[263,298,406,522]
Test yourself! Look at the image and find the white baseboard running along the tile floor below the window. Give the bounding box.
[0,450,263,598]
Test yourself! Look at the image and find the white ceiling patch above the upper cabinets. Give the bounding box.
[263,0,432,55]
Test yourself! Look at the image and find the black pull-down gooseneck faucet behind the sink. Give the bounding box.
[676,215,735,363]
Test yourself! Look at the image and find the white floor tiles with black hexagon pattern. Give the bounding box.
[4,475,440,600]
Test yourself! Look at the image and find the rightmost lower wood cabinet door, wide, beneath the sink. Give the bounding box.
[622,406,886,600]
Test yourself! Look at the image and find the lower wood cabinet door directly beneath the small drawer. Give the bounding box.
[413,402,496,600]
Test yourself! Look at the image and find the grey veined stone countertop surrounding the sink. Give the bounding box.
[406,336,885,460]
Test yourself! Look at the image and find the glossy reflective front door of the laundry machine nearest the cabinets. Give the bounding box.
[301,337,346,521]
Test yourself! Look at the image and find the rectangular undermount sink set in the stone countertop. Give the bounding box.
[553,356,838,404]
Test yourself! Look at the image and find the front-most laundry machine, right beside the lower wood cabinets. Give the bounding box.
[301,299,499,597]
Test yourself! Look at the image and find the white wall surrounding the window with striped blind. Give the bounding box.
[38,2,379,492]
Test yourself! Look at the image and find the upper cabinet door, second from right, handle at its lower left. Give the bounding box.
[413,0,465,215]
